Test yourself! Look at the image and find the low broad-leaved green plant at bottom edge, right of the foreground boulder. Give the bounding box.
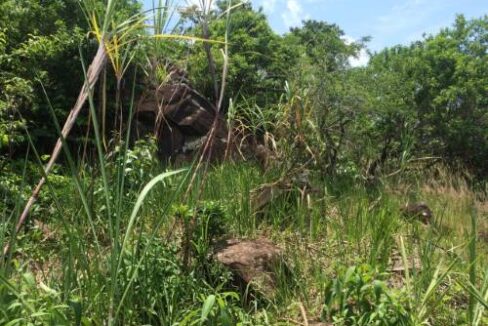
[323,265,412,326]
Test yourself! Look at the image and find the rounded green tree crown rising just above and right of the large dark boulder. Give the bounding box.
[188,1,291,105]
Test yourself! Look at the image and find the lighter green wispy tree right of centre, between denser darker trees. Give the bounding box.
[284,20,367,174]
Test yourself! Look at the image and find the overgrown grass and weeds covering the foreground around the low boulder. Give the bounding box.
[2,150,487,325]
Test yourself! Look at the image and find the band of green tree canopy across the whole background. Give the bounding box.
[0,0,488,176]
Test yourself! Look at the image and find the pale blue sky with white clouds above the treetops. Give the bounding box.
[144,0,488,65]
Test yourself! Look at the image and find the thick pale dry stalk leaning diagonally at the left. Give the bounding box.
[3,42,107,256]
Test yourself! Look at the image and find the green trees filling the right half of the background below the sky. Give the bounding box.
[268,16,488,180]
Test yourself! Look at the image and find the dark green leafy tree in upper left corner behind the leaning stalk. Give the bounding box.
[0,0,140,152]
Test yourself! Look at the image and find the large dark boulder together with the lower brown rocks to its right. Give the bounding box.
[132,65,280,169]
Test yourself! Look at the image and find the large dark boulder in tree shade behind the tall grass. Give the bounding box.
[133,68,227,160]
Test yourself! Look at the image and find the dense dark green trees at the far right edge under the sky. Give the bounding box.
[364,16,488,175]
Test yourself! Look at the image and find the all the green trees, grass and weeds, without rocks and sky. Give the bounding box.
[0,0,488,325]
